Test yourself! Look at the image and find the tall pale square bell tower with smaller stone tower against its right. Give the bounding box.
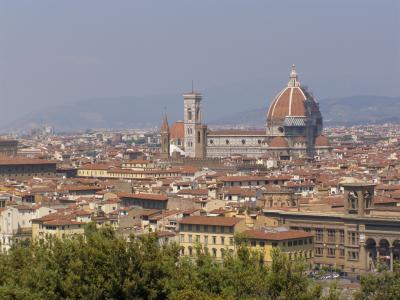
[183,91,207,158]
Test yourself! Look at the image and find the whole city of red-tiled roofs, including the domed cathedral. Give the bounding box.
[0,66,400,298]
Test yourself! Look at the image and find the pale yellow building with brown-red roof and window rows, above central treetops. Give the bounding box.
[179,216,246,260]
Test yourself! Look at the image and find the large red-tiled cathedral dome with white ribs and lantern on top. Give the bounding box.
[267,65,319,124]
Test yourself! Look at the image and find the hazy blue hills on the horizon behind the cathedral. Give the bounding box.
[2,94,400,131]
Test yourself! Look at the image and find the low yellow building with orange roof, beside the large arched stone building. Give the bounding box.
[242,230,314,263]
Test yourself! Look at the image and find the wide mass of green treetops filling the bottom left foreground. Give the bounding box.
[0,228,321,299]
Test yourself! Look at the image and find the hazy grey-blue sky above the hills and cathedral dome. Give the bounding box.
[0,0,400,121]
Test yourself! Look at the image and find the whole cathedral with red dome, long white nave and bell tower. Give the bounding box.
[160,65,331,160]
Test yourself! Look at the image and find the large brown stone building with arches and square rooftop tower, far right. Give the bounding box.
[264,183,400,277]
